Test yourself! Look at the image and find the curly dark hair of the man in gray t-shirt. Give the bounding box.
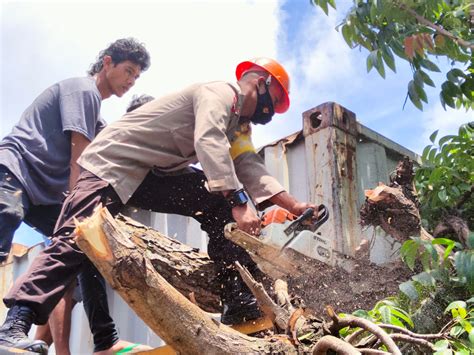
[87,38,150,76]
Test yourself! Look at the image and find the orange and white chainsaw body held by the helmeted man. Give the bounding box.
[259,205,332,263]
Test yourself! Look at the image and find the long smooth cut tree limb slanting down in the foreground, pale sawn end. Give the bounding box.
[75,208,295,355]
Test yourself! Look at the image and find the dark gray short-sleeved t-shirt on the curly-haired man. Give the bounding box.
[0,77,105,205]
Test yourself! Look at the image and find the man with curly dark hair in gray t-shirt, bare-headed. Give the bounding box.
[0,38,150,354]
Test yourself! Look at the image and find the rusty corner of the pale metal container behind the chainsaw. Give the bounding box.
[261,102,419,266]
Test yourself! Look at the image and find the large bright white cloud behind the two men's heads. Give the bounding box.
[0,0,279,135]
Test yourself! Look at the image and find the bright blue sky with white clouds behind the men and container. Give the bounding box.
[0,0,473,243]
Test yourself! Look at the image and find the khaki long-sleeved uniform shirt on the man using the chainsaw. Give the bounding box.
[78,82,284,204]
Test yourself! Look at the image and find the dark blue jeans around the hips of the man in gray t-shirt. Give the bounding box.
[0,165,61,262]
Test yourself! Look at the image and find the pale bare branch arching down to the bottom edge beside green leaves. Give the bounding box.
[326,307,402,355]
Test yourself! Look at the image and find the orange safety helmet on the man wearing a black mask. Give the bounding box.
[235,57,290,113]
